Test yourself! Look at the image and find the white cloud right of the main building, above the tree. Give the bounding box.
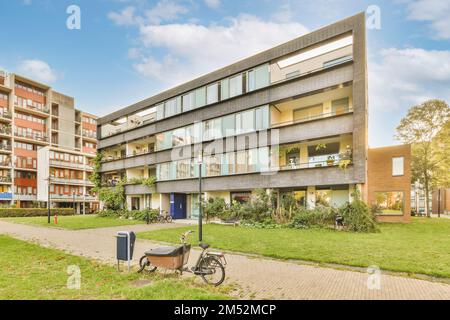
[369,48,450,111]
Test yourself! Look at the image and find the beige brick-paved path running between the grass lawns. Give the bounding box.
[0,221,450,300]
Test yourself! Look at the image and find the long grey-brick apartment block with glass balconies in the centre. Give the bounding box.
[98,14,368,218]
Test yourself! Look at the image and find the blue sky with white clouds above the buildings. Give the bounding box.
[0,0,450,147]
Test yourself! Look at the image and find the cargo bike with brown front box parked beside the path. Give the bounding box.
[138,231,227,286]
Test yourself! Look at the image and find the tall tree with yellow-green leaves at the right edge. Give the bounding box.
[396,99,450,217]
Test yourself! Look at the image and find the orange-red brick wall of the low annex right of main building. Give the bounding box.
[367,145,411,222]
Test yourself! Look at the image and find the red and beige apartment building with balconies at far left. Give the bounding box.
[0,72,98,212]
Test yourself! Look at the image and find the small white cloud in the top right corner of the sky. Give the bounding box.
[406,0,450,39]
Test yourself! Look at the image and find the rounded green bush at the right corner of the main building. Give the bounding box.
[339,199,378,232]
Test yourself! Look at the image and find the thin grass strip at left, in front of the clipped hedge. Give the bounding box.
[2,215,145,230]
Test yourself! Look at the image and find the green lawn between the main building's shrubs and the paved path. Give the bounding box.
[138,218,450,278]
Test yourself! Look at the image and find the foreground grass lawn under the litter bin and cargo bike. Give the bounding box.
[0,236,229,300]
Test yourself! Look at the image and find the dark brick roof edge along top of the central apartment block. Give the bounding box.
[98,12,365,125]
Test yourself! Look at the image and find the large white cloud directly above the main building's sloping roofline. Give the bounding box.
[134,15,308,85]
